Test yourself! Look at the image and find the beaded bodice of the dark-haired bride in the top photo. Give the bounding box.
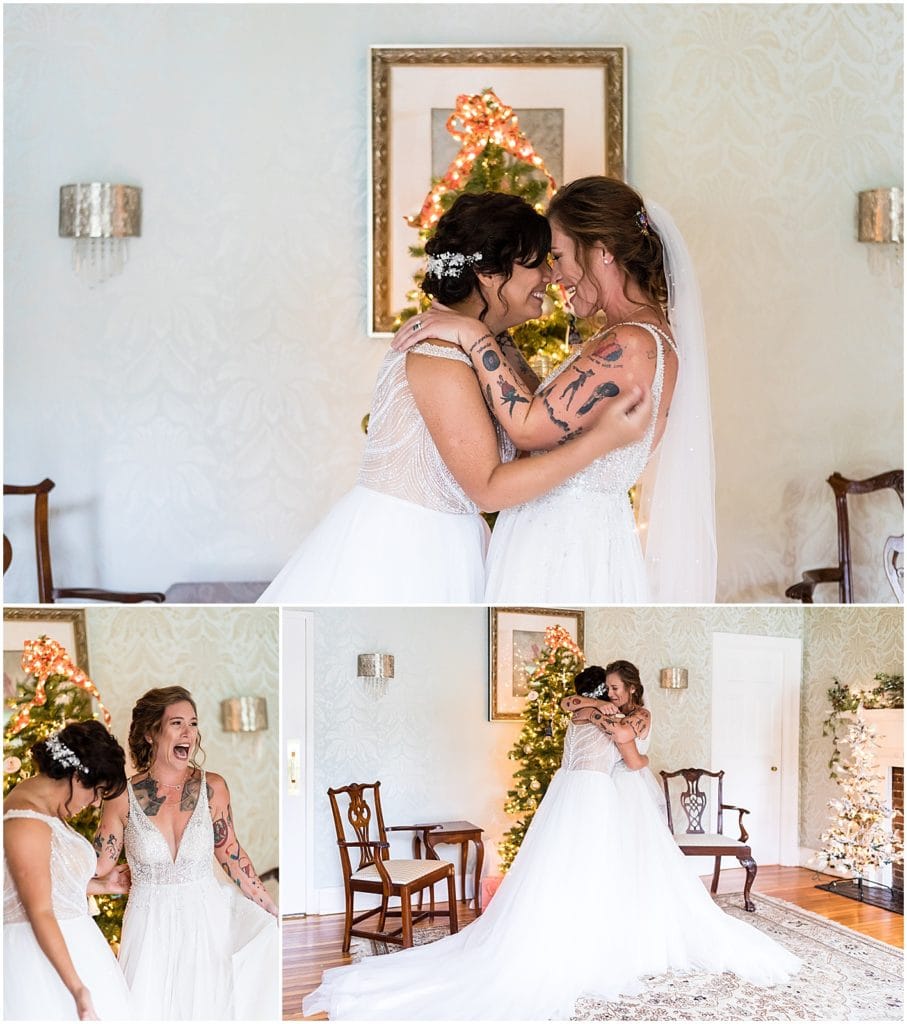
[359,342,516,514]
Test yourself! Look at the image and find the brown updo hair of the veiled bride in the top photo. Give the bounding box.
[548,175,667,313]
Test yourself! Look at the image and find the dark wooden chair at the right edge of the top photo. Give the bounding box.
[784,469,904,604]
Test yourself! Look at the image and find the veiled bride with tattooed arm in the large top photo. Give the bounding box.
[394,177,716,604]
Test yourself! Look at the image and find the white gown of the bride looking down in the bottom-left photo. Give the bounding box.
[3,810,131,1021]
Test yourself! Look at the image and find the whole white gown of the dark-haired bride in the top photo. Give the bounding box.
[259,342,515,604]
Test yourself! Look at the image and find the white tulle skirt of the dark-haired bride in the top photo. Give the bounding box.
[259,484,488,604]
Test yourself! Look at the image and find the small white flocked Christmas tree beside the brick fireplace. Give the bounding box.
[819,708,904,880]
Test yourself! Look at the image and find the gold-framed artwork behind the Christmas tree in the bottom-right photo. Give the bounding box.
[488,608,584,722]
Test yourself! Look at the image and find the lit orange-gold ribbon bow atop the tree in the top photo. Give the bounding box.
[406,89,557,229]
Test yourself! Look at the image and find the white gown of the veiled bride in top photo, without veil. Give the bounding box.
[485,322,673,605]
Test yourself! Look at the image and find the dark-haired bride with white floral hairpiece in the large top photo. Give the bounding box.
[260,193,650,604]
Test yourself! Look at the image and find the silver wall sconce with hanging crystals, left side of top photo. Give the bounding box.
[59,181,141,288]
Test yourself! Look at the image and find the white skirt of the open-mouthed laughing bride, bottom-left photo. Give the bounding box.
[120,874,279,1020]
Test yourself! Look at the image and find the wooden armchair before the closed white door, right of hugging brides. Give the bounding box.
[660,768,757,913]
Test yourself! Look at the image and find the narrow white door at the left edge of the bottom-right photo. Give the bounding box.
[280,608,314,915]
